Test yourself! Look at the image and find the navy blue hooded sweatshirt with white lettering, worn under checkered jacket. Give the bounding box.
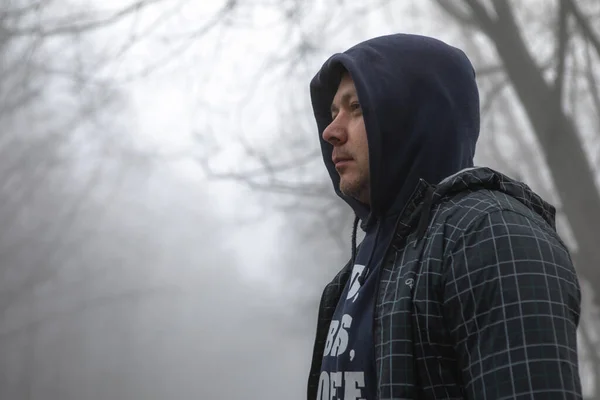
[310,34,479,400]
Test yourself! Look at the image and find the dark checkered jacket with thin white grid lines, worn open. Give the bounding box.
[308,168,582,400]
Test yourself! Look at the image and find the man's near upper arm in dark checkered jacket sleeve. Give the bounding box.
[444,211,582,400]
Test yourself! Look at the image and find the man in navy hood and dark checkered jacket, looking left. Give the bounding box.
[308,35,581,400]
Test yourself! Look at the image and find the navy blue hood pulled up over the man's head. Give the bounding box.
[310,34,479,229]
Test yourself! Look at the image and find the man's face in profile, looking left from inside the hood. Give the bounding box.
[323,73,370,204]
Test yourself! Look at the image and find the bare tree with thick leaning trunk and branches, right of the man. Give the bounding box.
[436,0,600,394]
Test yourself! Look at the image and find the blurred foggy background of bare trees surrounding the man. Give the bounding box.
[0,0,600,400]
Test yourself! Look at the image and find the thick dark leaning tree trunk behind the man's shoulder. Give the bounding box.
[483,2,600,304]
